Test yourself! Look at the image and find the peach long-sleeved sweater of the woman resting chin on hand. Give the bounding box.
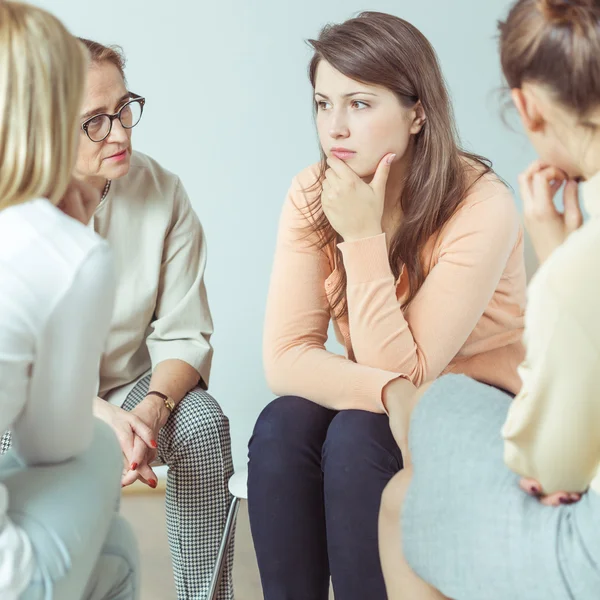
[263,165,526,412]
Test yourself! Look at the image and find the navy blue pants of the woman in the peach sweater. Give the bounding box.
[248,396,402,600]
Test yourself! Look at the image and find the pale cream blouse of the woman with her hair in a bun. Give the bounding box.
[503,174,600,493]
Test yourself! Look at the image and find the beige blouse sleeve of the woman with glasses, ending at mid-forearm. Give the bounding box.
[147,181,213,388]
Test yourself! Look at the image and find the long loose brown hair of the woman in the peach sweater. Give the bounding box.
[306,12,491,318]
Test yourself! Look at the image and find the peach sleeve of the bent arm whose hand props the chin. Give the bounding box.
[340,185,521,386]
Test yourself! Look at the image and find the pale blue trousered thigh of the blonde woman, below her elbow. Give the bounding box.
[5,422,126,600]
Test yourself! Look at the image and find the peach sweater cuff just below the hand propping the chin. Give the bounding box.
[338,233,393,284]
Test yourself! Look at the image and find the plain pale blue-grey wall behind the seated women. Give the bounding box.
[29,0,533,467]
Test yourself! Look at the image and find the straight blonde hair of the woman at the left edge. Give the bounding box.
[0,1,89,210]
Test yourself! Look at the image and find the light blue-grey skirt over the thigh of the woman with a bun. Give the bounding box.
[401,376,575,600]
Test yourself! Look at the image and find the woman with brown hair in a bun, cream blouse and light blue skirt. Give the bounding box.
[380,0,600,600]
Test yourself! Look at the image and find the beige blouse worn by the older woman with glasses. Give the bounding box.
[91,152,213,405]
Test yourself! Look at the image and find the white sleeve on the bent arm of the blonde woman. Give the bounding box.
[11,242,115,465]
